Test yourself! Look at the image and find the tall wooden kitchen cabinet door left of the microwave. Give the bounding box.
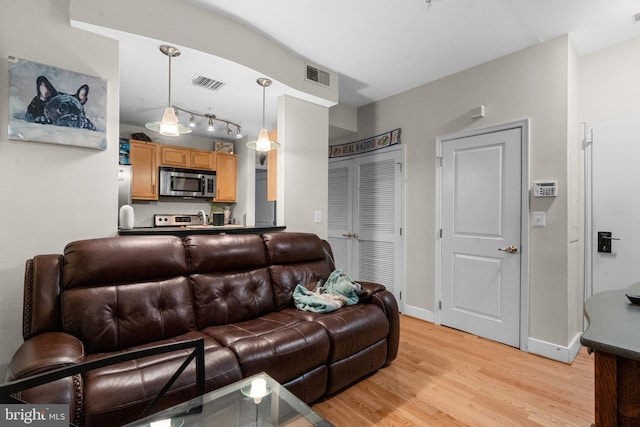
[129,140,158,200]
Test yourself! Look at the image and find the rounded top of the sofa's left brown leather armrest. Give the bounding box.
[7,332,85,381]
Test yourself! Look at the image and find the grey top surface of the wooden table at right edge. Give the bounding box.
[580,282,640,360]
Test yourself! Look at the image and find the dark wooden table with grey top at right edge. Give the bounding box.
[580,282,640,427]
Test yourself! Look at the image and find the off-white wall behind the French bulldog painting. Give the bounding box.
[0,0,119,372]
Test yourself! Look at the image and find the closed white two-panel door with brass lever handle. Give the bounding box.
[440,128,522,347]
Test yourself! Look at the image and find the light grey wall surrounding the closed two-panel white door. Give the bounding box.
[332,37,578,358]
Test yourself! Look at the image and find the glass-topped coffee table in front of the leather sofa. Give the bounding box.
[127,372,333,427]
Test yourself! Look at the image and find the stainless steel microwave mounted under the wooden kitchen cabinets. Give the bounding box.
[160,167,216,198]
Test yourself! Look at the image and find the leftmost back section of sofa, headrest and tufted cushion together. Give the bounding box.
[60,236,196,353]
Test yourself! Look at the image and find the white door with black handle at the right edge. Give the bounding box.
[585,116,640,297]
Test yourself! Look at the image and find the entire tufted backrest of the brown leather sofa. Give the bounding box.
[23,232,334,353]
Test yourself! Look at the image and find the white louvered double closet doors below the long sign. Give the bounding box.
[328,148,403,306]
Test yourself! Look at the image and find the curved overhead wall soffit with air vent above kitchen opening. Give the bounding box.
[68,0,338,106]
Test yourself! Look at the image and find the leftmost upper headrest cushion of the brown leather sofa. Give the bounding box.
[62,236,187,289]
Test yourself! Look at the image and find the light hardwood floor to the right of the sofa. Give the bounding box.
[313,315,594,427]
